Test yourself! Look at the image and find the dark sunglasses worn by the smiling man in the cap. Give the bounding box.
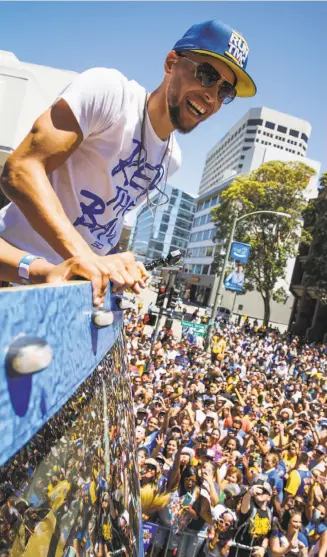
[176,52,236,104]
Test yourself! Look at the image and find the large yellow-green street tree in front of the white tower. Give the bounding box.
[212,161,315,325]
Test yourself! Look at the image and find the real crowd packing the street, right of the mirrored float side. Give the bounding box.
[125,308,327,557]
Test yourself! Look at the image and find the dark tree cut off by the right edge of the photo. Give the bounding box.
[304,172,327,304]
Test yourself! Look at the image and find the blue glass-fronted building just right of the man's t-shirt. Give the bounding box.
[130,184,196,261]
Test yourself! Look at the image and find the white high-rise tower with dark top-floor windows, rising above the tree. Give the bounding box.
[199,107,311,195]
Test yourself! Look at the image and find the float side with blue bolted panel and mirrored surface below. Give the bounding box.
[0,281,143,557]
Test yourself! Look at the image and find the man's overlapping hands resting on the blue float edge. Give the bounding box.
[34,252,149,306]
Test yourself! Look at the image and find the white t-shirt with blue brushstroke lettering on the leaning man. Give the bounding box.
[0,68,181,263]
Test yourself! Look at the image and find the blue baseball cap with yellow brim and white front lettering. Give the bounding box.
[173,20,257,97]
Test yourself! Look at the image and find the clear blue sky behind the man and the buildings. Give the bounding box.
[0,1,327,200]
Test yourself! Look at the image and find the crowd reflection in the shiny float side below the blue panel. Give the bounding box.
[0,338,141,557]
